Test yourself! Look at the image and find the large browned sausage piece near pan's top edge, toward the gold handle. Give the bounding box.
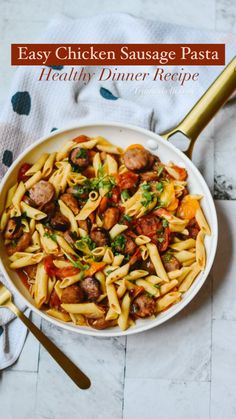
[124,147,150,171]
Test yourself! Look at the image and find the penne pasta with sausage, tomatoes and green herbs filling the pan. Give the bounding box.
[0,135,211,331]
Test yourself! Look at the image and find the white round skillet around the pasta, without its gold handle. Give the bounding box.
[0,122,218,337]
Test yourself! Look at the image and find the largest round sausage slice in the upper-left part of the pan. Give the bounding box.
[29,180,55,207]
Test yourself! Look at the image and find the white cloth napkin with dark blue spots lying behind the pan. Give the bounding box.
[0,14,236,369]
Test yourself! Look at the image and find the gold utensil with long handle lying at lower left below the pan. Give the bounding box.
[0,282,91,390]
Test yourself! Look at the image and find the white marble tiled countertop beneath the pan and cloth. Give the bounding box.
[0,0,236,419]
